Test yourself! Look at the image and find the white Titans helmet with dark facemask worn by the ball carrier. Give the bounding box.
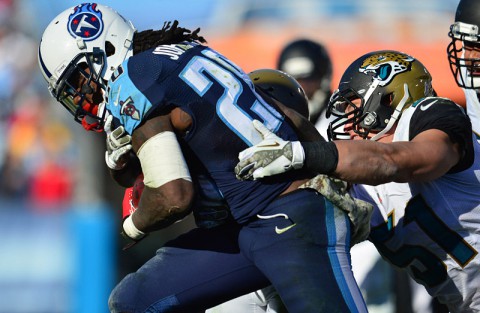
[38,3,136,131]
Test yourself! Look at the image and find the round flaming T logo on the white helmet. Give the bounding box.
[68,3,103,41]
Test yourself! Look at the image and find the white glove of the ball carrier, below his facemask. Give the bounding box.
[103,115,132,170]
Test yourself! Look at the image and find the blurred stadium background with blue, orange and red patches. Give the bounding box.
[0,0,464,313]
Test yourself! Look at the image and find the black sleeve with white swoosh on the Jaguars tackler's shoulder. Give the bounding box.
[409,97,473,172]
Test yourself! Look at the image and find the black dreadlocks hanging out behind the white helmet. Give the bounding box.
[133,20,207,54]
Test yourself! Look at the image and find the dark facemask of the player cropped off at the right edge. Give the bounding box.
[447,22,480,89]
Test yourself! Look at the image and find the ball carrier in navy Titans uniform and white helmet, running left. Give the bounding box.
[39,3,366,312]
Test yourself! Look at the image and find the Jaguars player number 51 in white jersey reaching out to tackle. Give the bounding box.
[236,51,480,312]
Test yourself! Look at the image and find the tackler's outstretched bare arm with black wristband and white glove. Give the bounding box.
[235,123,461,185]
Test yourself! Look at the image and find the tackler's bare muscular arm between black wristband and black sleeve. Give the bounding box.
[334,129,461,185]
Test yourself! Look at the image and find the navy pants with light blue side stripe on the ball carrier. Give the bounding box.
[109,190,367,313]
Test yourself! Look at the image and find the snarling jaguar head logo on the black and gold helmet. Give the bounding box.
[359,52,415,86]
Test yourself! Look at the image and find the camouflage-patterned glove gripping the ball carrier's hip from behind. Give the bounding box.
[298,175,373,246]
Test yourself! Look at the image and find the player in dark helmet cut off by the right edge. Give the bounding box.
[447,0,480,140]
